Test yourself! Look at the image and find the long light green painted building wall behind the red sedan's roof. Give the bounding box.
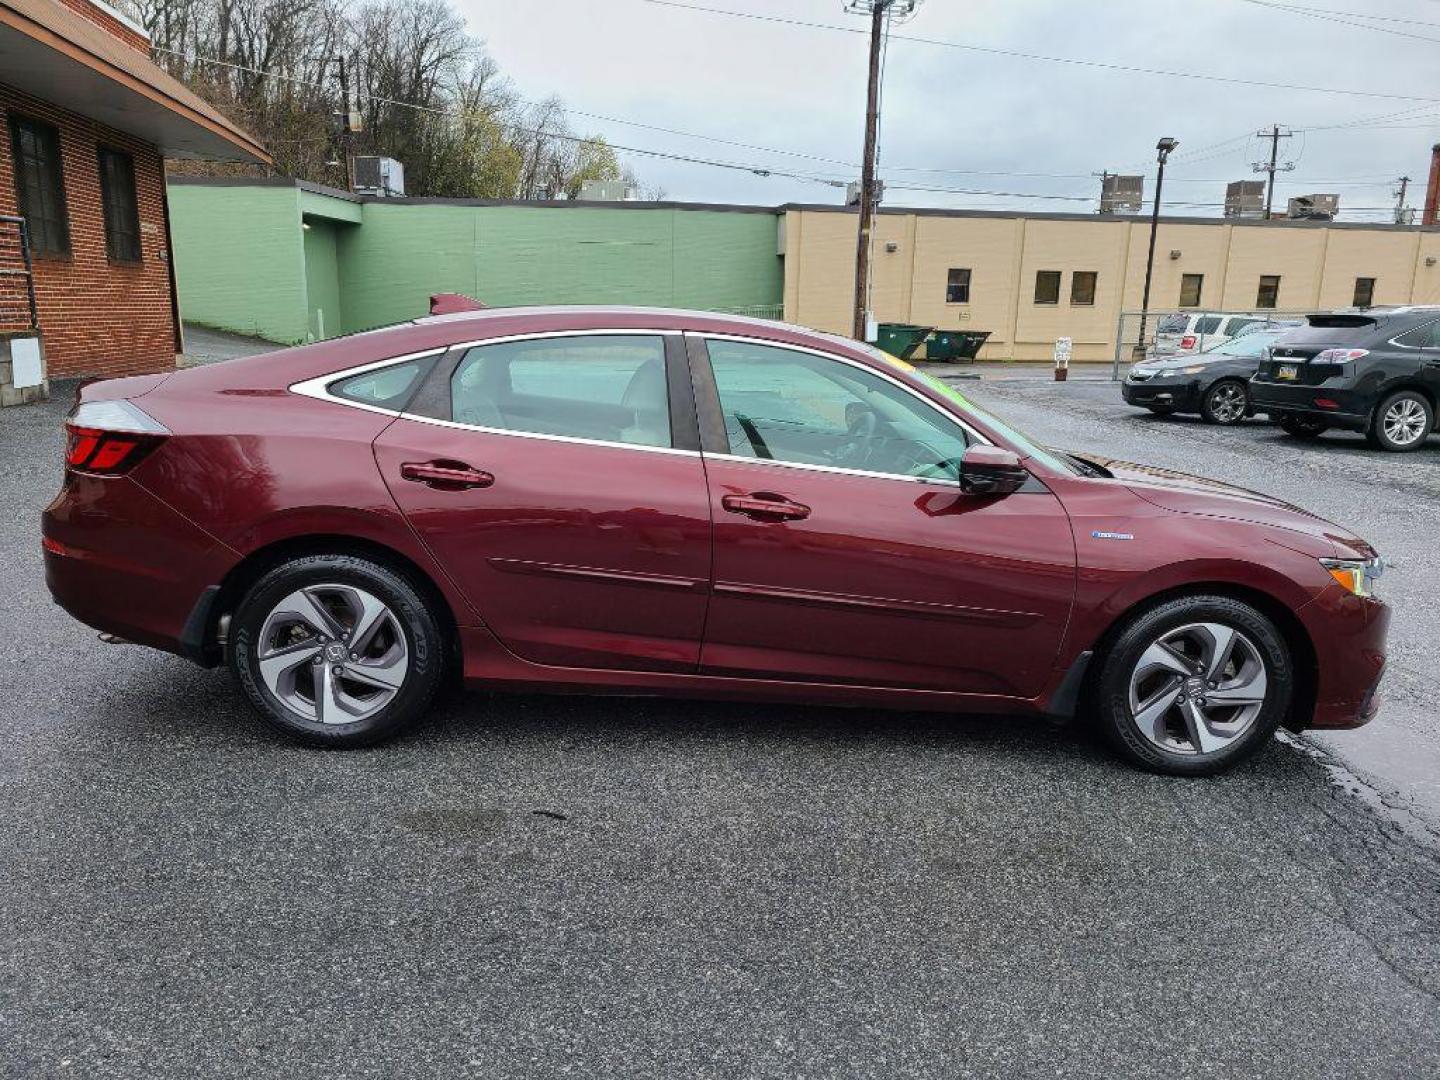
[170,183,785,341]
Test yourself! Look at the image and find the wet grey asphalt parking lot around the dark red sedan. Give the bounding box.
[0,382,1440,1080]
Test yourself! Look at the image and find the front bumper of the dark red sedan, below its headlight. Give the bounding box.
[1297,586,1390,729]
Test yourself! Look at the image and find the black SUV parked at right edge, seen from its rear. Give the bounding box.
[1250,307,1440,451]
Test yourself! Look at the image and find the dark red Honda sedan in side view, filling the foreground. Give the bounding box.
[45,308,1388,773]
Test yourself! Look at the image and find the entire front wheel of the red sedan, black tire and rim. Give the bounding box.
[1093,596,1295,776]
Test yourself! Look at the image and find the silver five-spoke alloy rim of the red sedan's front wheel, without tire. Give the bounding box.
[1129,622,1269,755]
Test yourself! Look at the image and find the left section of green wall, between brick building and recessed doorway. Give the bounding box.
[168,183,308,343]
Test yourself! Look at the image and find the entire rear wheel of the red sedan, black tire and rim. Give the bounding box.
[228,554,446,747]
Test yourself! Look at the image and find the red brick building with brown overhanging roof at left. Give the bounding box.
[0,0,269,390]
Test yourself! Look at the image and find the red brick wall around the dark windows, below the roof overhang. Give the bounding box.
[0,84,176,379]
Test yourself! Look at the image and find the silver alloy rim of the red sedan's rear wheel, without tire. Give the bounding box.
[256,585,410,724]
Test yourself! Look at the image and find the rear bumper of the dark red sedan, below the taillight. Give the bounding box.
[40,474,239,660]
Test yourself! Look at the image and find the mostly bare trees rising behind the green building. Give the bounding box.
[122,0,648,199]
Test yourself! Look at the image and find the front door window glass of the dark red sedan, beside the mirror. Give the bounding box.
[706,340,968,480]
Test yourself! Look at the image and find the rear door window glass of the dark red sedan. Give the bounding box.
[451,336,671,446]
